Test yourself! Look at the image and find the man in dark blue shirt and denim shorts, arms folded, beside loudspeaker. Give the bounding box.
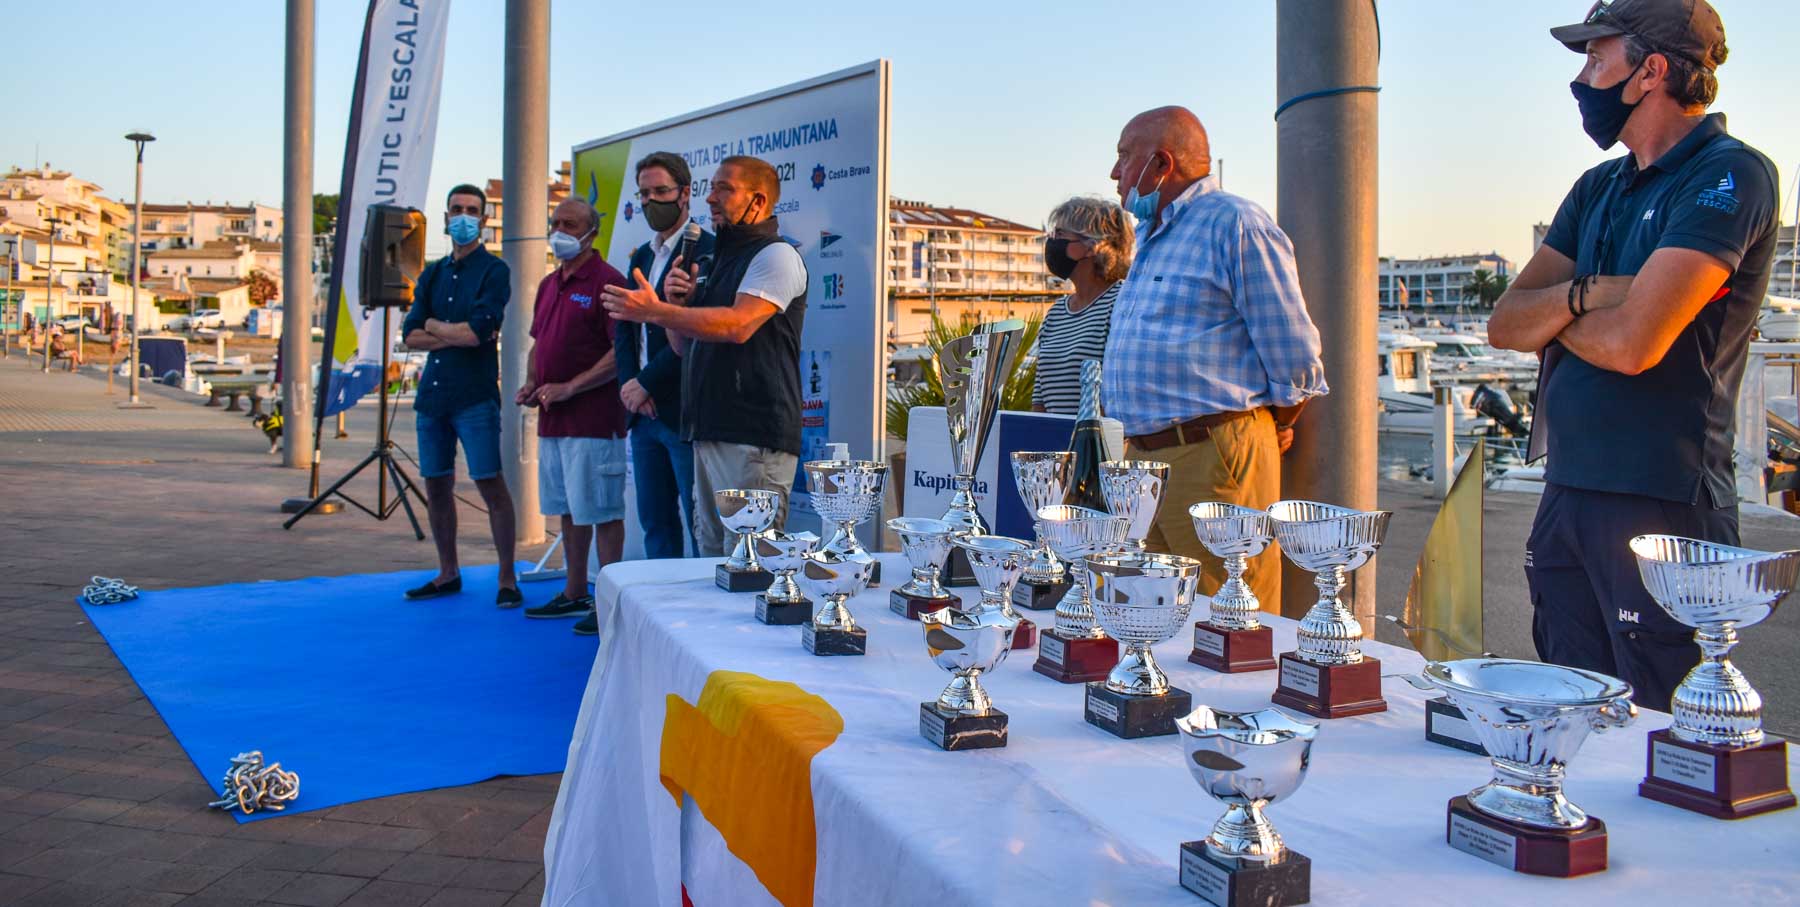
[401,184,524,608]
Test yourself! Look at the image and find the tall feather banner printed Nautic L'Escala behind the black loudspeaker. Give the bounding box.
[319,0,450,421]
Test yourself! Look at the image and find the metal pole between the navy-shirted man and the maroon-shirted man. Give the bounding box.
[500,0,551,545]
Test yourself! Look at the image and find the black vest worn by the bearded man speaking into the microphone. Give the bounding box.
[682,218,806,457]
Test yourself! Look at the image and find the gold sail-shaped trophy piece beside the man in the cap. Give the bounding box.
[1406,441,1487,660]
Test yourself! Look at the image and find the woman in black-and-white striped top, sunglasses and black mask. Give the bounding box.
[1031,196,1132,416]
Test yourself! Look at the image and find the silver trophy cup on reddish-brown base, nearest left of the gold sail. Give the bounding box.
[1269,500,1393,718]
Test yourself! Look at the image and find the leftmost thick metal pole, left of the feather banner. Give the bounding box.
[281,0,313,470]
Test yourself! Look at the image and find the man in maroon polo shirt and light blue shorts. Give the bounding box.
[517,198,625,635]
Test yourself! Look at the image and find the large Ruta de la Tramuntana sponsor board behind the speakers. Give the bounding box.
[572,61,889,534]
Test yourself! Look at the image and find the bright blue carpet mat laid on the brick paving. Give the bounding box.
[83,565,598,821]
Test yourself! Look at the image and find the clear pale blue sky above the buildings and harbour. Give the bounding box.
[0,0,1800,263]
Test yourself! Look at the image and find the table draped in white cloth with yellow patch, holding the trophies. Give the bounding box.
[544,554,1800,907]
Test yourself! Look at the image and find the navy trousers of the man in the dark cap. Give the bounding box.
[1525,484,1737,711]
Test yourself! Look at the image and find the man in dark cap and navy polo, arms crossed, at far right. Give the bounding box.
[1489,0,1777,709]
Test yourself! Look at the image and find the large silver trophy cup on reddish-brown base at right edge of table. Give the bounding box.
[1631,534,1800,819]
